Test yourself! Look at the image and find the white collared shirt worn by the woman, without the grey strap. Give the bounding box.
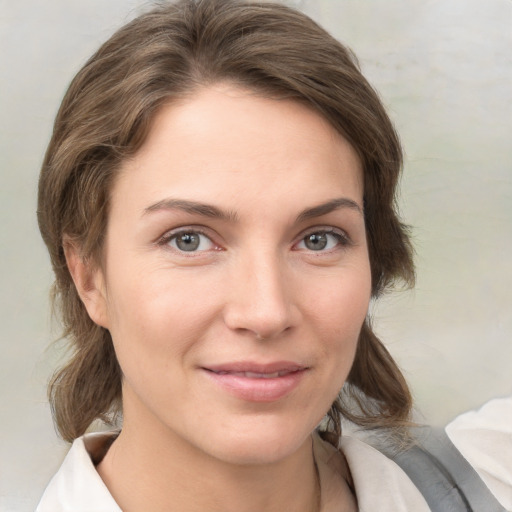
[36,397,512,512]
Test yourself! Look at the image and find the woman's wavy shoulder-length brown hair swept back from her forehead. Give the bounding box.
[37,0,414,445]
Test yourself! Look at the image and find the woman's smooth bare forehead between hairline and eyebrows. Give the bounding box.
[114,84,363,218]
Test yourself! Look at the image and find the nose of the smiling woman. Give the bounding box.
[224,253,300,340]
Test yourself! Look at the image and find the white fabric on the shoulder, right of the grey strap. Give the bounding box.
[446,396,512,510]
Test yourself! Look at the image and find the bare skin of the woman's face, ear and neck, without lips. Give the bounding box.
[67,84,371,512]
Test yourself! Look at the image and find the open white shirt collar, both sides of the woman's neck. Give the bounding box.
[36,433,430,512]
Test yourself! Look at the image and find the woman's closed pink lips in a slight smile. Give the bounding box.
[201,361,309,402]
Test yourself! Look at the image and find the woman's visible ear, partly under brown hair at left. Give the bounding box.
[63,237,109,329]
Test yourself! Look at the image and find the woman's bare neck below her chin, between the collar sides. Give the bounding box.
[98,411,320,512]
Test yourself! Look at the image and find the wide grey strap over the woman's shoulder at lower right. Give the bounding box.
[388,427,507,512]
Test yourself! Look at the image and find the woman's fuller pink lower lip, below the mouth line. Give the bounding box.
[203,369,307,402]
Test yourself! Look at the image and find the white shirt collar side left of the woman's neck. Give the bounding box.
[36,432,121,512]
